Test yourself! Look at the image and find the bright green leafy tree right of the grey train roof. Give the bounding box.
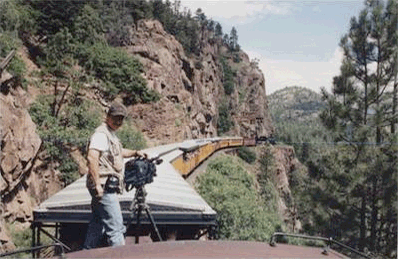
[197,156,281,241]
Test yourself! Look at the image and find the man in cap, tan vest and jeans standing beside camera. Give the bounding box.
[83,103,147,249]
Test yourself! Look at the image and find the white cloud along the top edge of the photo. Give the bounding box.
[181,0,292,23]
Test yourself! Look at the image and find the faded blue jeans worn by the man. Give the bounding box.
[83,193,126,249]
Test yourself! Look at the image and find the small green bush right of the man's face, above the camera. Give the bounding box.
[116,120,147,150]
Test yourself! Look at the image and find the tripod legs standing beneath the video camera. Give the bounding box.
[128,185,162,244]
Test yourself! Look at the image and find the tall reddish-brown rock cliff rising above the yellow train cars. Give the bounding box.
[126,21,273,143]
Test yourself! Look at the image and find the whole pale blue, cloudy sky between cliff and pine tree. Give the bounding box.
[181,0,364,94]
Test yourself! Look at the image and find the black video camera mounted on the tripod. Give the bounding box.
[124,156,163,191]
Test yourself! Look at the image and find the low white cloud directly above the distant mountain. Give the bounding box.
[246,48,343,94]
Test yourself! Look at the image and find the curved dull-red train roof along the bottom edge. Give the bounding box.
[64,241,348,259]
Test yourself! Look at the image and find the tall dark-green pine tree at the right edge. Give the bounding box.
[321,0,398,256]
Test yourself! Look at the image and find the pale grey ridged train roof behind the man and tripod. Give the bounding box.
[33,140,216,225]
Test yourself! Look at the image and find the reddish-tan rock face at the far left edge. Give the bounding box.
[0,72,60,252]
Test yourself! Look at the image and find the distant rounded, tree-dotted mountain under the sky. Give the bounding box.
[268,86,326,123]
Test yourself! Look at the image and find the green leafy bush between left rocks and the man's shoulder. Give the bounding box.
[29,95,101,185]
